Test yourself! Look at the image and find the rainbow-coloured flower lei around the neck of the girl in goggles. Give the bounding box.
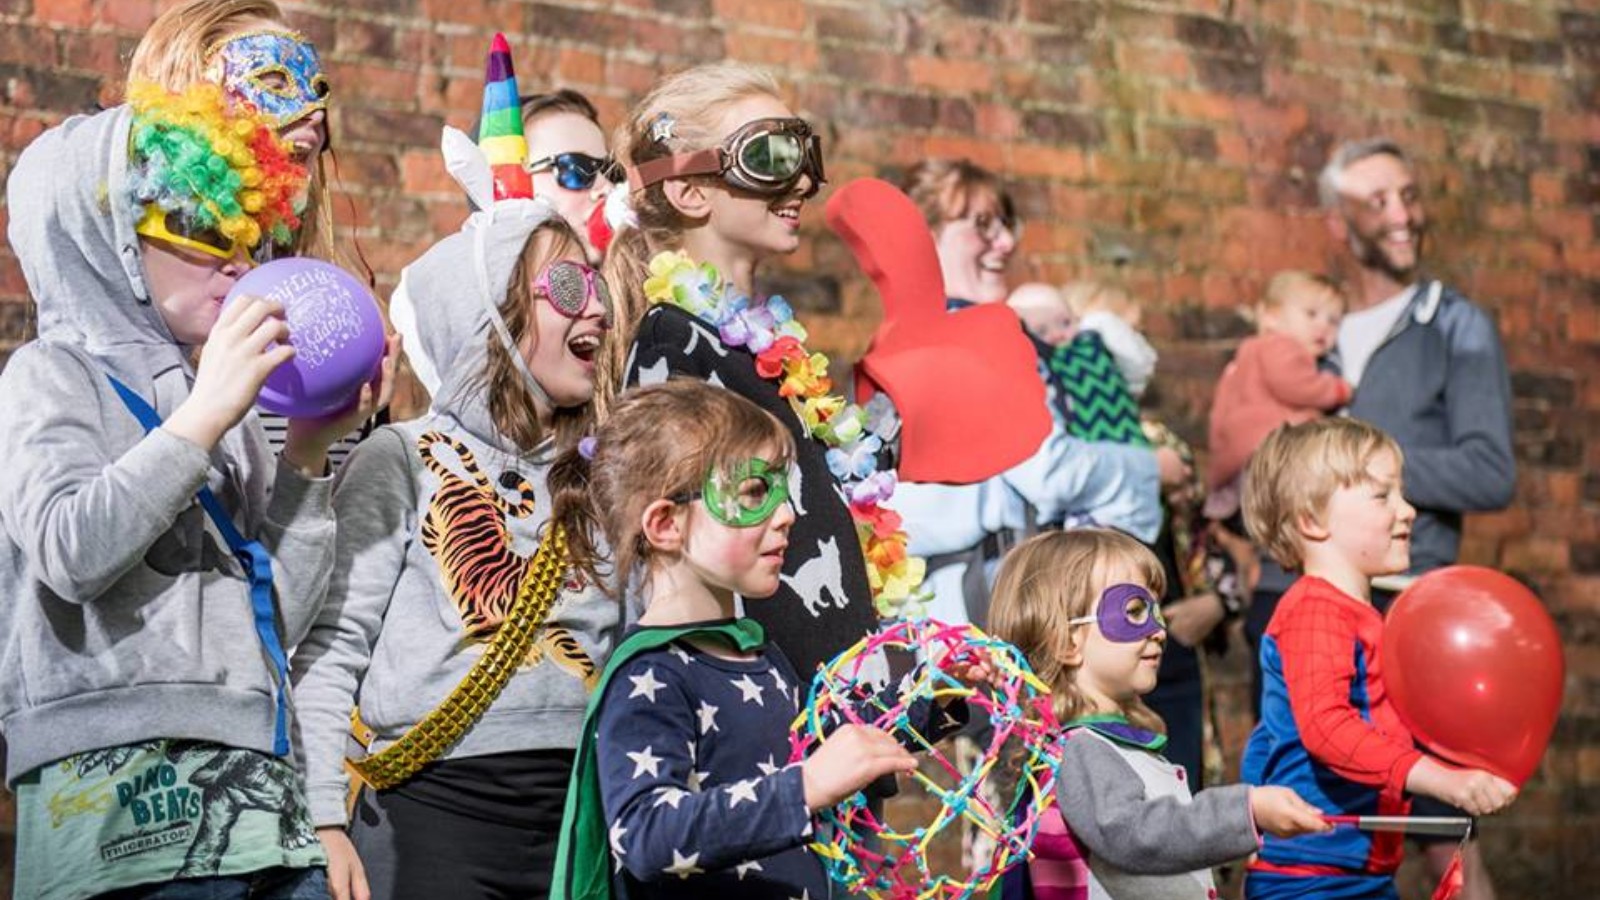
[645,251,928,618]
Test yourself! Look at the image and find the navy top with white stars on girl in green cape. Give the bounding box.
[595,642,829,900]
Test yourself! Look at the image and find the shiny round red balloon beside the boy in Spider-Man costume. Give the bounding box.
[1382,565,1565,786]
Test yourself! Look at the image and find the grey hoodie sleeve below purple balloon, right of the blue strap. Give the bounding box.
[259,458,334,647]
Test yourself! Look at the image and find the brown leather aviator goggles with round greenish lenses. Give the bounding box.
[627,119,827,199]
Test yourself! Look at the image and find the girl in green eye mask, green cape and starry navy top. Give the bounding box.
[550,380,915,898]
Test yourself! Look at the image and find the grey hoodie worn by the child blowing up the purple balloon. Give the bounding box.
[0,107,334,781]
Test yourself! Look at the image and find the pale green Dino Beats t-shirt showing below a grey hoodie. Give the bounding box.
[16,740,326,900]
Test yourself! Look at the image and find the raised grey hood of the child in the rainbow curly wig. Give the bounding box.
[6,106,189,390]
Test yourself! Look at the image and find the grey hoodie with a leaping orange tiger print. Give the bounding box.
[294,171,621,826]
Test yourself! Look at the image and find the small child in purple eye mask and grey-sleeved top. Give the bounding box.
[989,528,1328,900]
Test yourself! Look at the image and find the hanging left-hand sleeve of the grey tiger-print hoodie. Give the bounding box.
[294,428,416,826]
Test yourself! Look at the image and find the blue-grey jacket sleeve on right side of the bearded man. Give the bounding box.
[1402,301,1517,512]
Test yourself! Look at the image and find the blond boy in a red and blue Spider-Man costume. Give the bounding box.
[1240,418,1517,898]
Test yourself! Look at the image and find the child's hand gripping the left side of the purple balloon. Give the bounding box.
[162,296,294,450]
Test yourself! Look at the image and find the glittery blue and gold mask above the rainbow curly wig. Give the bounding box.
[206,30,330,127]
